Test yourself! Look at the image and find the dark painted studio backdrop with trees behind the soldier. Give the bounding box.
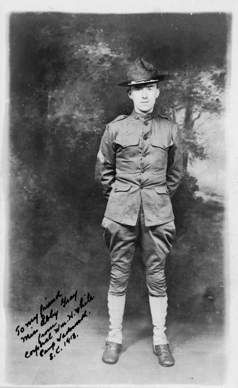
[7,13,230,328]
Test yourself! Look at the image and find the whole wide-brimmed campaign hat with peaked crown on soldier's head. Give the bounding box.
[117,57,170,86]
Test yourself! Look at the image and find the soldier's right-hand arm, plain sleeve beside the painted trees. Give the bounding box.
[166,123,183,197]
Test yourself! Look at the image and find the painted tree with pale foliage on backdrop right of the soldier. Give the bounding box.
[160,66,226,229]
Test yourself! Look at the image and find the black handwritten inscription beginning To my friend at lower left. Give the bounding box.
[16,290,94,360]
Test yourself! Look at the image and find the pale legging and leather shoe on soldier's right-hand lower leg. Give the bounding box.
[149,295,175,366]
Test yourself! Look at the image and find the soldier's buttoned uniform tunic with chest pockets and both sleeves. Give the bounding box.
[98,112,182,226]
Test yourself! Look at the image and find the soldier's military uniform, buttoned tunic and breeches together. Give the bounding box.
[98,111,182,296]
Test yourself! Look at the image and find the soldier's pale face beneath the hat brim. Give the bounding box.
[128,83,160,113]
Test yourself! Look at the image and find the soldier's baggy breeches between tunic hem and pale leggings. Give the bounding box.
[102,209,175,296]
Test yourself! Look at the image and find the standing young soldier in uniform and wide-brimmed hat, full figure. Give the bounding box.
[97,58,182,367]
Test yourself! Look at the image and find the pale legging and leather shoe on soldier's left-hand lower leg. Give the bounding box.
[102,294,126,364]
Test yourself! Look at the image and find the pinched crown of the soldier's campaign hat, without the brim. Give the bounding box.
[127,57,158,81]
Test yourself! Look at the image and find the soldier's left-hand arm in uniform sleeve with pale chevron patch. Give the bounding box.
[95,126,116,199]
